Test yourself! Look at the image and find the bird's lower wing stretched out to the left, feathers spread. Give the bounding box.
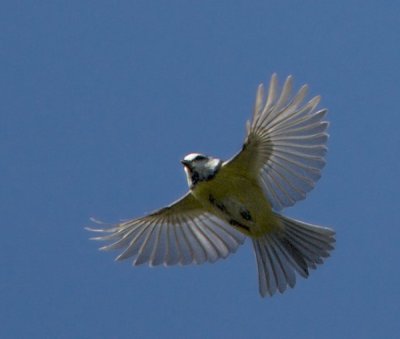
[88,192,245,266]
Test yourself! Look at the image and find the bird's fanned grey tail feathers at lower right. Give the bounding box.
[252,214,335,297]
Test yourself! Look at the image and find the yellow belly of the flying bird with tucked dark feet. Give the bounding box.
[193,178,278,237]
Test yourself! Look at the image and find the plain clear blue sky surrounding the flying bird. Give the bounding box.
[0,0,400,339]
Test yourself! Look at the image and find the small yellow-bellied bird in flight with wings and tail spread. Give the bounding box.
[87,73,335,297]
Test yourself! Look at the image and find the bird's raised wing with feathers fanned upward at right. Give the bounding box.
[224,74,328,210]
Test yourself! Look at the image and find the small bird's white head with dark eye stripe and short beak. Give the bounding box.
[181,153,222,188]
